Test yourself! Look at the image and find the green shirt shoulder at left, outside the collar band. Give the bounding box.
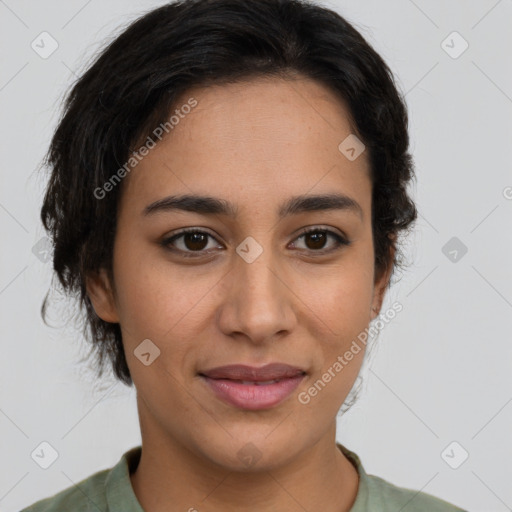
[21,469,111,512]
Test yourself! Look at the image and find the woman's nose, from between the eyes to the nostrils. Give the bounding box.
[217,242,297,344]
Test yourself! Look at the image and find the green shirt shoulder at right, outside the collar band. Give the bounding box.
[366,475,465,512]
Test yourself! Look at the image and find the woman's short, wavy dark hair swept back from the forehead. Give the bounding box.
[41,0,416,386]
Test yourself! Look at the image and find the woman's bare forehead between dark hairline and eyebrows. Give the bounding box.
[118,78,369,217]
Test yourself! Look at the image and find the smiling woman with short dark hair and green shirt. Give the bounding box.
[22,0,461,512]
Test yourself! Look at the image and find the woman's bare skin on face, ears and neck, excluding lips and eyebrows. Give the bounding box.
[87,77,392,512]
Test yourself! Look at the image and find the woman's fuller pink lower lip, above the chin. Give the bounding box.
[201,375,305,411]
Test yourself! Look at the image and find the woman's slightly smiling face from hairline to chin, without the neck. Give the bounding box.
[88,75,389,470]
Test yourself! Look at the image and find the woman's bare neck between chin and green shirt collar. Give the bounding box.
[130,423,358,512]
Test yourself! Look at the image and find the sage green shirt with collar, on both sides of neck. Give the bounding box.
[21,443,466,512]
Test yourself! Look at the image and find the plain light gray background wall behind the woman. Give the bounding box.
[0,0,512,512]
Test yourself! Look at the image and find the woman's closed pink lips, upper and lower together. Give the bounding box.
[199,363,306,410]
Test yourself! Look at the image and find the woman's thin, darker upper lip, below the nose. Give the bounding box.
[199,363,306,382]
